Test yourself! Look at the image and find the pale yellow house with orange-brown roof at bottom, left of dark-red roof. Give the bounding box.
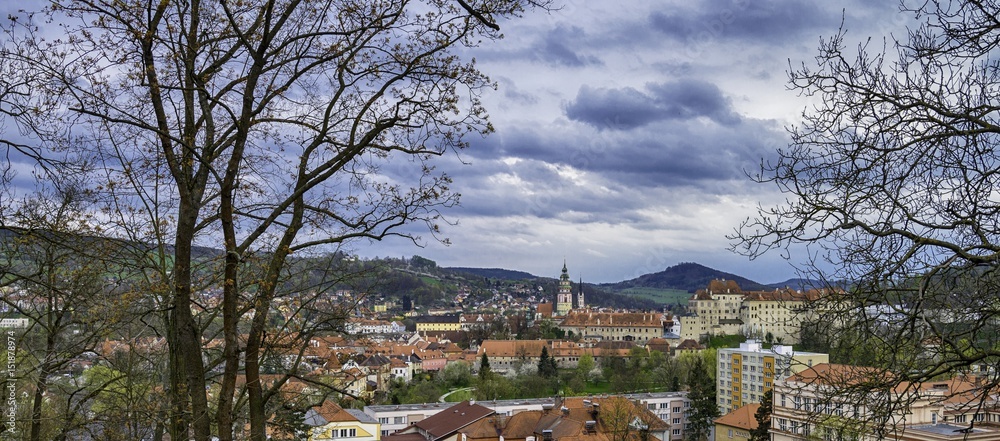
[303,400,382,441]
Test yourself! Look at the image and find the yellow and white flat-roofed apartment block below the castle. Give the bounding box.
[715,340,830,415]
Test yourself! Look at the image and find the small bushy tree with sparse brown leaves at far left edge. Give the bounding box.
[0,186,145,440]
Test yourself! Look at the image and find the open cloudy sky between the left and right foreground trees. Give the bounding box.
[357,0,908,283]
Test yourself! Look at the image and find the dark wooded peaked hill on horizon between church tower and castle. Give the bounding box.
[604,262,767,292]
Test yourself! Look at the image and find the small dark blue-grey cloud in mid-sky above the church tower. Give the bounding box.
[566,79,740,130]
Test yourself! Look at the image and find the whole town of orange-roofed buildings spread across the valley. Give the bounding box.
[3,257,1000,441]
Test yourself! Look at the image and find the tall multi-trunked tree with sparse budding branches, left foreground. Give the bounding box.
[0,0,545,440]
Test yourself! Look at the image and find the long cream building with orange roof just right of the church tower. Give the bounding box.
[559,310,673,343]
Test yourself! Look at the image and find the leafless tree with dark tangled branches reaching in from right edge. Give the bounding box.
[734,1,1000,434]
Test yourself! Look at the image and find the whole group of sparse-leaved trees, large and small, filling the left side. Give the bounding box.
[0,0,545,441]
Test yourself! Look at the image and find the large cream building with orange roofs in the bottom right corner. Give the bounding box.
[770,363,1000,441]
